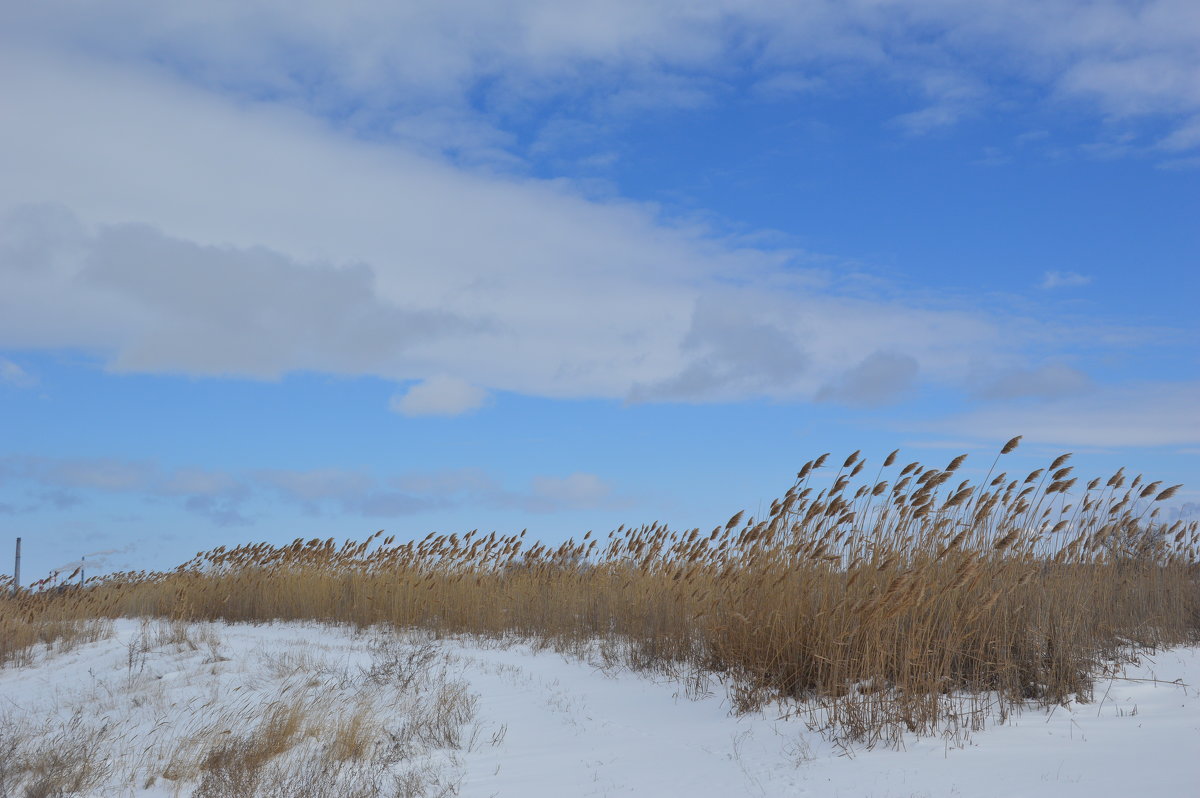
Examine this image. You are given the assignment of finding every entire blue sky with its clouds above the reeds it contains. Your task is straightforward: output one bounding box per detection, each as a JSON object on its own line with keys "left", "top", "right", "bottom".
{"left": 0, "top": 0, "right": 1200, "bottom": 580}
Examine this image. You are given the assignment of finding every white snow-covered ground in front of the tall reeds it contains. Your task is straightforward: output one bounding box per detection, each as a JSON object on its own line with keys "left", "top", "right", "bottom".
{"left": 0, "top": 620, "right": 1200, "bottom": 798}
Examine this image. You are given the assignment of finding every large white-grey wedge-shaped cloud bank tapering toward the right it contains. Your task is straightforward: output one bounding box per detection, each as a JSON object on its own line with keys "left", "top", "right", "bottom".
{"left": 0, "top": 50, "right": 1032, "bottom": 407}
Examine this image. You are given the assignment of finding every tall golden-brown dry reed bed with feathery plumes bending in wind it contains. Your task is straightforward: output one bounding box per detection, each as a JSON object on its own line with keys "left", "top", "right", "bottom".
{"left": 0, "top": 438, "right": 1200, "bottom": 743}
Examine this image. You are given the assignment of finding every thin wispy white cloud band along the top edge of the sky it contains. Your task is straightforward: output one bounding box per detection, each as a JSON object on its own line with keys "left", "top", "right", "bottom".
{"left": 0, "top": 0, "right": 1200, "bottom": 151}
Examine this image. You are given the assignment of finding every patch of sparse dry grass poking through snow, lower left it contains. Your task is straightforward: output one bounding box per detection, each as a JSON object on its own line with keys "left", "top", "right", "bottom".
{"left": 0, "top": 620, "right": 475, "bottom": 798}
